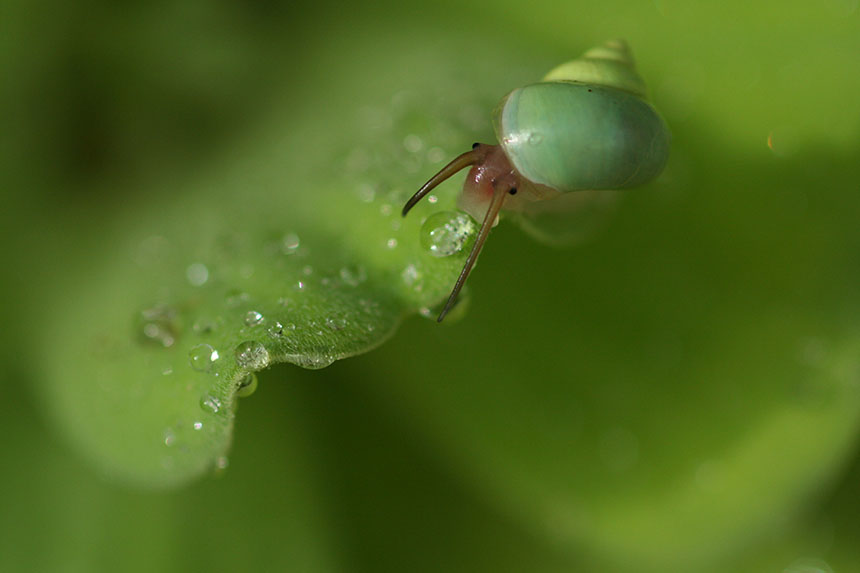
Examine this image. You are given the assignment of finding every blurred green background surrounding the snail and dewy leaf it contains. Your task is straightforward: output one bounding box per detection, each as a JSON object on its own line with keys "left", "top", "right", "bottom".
{"left": 0, "top": 0, "right": 860, "bottom": 572}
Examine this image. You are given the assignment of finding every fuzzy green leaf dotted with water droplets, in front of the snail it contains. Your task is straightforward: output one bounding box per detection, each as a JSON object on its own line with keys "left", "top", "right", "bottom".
{"left": 35, "top": 45, "right": 510, "bottom": 487}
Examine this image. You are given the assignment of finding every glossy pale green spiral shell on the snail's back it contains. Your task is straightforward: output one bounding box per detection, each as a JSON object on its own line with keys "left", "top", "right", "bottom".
{"left": 494, "top": 41, "right": 670, "bottom": 192}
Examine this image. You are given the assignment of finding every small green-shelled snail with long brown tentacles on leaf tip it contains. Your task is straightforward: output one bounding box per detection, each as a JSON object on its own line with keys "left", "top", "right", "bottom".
{"left": 403, "top": 40, "right": 670, "bottom": 322}
